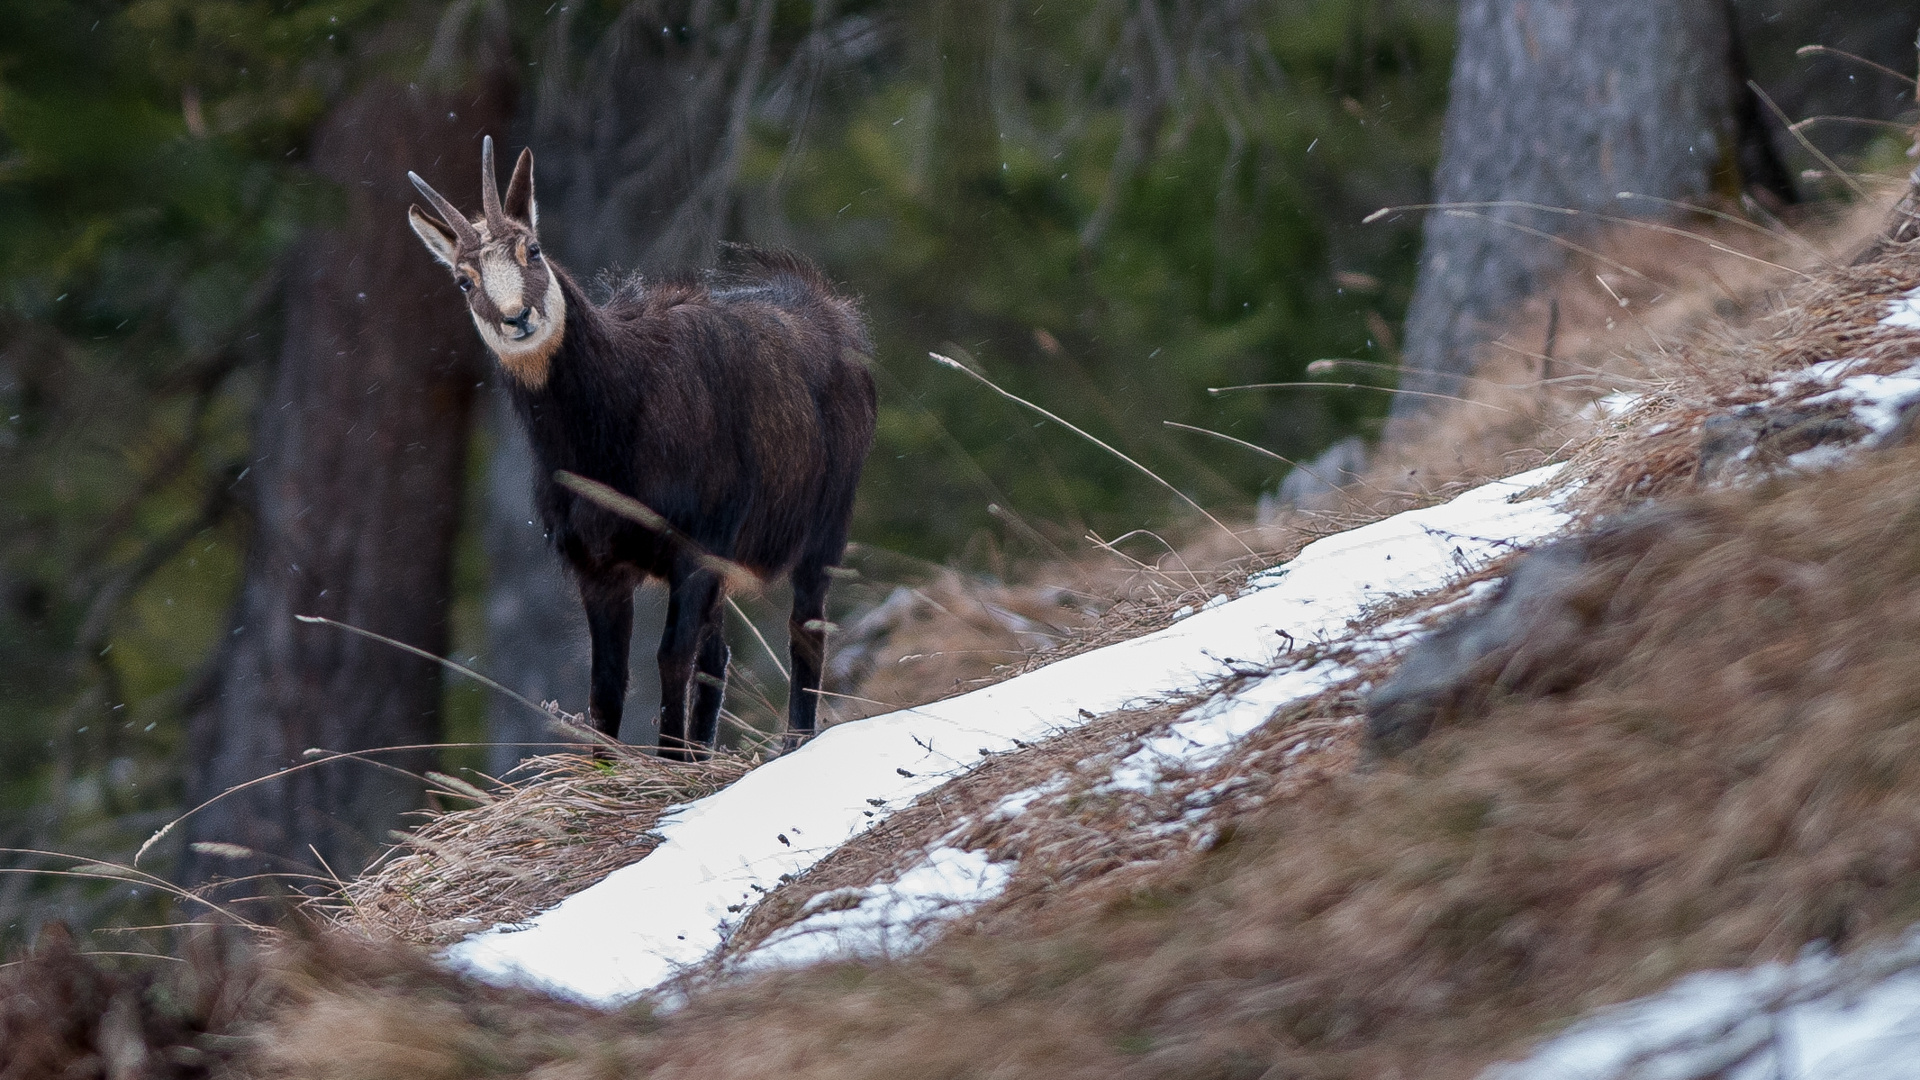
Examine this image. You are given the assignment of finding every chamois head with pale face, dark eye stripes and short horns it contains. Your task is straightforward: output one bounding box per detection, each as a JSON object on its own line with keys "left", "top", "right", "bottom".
{"left": 407, "top": 135, "right": 566, "bottom": 390}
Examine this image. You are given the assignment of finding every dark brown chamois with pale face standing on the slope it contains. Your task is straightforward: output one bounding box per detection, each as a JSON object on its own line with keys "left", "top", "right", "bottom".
{"left": 407, "top": 136, "right": 876, "bottom": 761}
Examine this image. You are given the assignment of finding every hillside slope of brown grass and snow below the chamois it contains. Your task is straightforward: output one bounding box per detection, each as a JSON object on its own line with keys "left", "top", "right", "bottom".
{"left": 15, "top": 180, "right": 1920, "bottom": 1080}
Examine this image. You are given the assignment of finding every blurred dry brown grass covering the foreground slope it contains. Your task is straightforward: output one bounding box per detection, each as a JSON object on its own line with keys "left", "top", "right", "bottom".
{"left": 337, "top": 432, "right": 1920, "bottom": 1078}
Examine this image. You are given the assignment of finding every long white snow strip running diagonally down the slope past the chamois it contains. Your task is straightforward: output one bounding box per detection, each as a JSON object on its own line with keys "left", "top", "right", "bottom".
{"left": 447, "top": 457, "right": 1569, "bottom": 1003}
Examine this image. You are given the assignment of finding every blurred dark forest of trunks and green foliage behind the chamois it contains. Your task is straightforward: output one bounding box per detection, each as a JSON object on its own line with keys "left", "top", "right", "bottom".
{"left": 0, "top": 0, "right": 1912, "bottom": 944}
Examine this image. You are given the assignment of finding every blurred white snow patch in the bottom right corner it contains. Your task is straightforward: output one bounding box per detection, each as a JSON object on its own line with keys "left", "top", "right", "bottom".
{"left": 1482, "top": 930, "right": 1920, "bottom": 1080}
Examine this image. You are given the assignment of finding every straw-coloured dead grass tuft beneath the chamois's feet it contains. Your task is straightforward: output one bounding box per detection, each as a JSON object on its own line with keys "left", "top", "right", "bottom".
{"left": 323, "top": 749, "right": 755, "bottom": 945}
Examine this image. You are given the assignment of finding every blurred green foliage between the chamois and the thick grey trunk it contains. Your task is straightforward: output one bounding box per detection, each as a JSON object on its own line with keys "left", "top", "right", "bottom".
{"left": 753, "top": 0, "right": 1452, "bottom": 559}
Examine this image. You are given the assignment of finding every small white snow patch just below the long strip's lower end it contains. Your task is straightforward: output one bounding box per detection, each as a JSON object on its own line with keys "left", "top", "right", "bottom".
{"left": 739, "top": 847, "right": 1012, "bottom": 970}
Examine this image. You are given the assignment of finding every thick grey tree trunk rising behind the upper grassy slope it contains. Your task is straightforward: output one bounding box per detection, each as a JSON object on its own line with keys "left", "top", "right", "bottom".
{"left": 1394, "top": 0, "right": 1793, "bottom": 419}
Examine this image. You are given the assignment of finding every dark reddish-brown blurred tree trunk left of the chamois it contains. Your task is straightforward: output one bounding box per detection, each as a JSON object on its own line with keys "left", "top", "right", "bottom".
{"left": 180, "top": 79, "right": 509, "bottom": 892}
